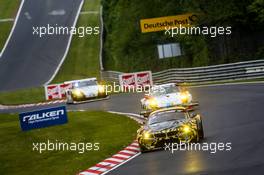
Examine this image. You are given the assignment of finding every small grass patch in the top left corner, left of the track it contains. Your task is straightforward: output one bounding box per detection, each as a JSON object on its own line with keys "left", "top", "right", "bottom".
{"left": 0, "top": 0, "right": 20, "bottom": 51}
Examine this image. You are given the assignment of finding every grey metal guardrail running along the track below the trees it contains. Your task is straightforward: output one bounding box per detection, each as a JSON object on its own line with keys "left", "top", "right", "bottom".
{"left": 102, "top": 60, "right": 264, "bottom": 84}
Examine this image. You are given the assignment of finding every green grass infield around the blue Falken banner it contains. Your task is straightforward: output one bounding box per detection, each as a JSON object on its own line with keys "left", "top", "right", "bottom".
{"left": 0, "top": 111, "right": 138, "bottom": 175}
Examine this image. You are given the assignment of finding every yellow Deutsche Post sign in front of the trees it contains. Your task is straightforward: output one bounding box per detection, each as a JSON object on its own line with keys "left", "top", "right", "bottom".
{"left": 140, "top": 13, "right": 197, "bottom": 33}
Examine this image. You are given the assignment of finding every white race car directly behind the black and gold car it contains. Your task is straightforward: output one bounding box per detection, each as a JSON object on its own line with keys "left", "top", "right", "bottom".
{"left": 140, "top": 83, "right": 198, "bottom": 117}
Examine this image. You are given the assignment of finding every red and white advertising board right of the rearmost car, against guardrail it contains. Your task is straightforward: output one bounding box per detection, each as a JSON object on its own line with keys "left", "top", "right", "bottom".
{"left": 119, "top": 71, "right": 153, "bottom": 89}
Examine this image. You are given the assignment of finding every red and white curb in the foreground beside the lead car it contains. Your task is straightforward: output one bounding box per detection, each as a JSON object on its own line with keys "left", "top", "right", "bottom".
{"left": 78, "top": 141, "right": 141, "bottom": 175}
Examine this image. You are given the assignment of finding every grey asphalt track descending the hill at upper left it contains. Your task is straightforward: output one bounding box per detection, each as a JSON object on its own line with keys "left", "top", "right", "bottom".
{"left": 0, "top": 0, "right": 83, "bottom": 91}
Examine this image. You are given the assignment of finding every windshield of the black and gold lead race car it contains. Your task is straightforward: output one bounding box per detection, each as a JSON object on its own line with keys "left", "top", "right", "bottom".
{"left": 148, "top": 111, "right": 185, "bottom": 125}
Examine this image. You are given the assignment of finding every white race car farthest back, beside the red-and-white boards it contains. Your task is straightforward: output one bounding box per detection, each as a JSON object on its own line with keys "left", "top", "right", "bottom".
{"left": 65, "top": 78, "right": 108, "bottom": 103}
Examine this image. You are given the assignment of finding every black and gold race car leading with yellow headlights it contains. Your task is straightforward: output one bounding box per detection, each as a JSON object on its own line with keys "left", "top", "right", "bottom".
{"left": 137, "top": 107, "right": 204, "bottom": 152}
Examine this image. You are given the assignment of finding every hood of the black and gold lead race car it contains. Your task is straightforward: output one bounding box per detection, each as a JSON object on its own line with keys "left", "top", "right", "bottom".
{"left": 148, "top": 119, "right": 187, "bottom": 132}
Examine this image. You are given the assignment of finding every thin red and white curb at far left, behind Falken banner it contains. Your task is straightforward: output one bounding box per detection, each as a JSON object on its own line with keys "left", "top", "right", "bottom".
{"left": 0, "top": 100, "right": 66, "bottom": 110}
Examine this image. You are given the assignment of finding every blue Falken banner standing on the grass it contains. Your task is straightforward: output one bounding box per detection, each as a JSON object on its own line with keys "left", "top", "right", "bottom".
{"left": 19, "top": 106, "right": 68, "bottom": 131}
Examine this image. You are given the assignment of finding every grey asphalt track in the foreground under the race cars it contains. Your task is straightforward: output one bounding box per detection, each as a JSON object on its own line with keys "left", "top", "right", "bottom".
{"left": 2, "top": 84, "right": 264, "bottom": 175}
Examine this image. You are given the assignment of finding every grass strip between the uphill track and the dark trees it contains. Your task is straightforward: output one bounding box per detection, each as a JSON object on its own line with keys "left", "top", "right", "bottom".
{"left": 52, "top": 0, "right": 100, "bottom": 83}
